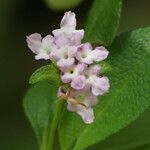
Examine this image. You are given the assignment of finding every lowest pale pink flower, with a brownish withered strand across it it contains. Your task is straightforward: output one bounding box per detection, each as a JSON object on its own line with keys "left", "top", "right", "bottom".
{"left": 58, "top": 88, "right": 97, "bottom": 124}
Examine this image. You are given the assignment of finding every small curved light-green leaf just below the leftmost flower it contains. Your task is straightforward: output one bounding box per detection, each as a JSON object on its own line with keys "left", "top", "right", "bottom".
{"left": 29, "top": 64, "right": 61, "bottom": 86}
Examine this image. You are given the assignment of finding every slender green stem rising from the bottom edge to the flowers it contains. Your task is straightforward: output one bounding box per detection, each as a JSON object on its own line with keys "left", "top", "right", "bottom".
{"left": 47, "top": 100, "right": 64, "bottom": 150}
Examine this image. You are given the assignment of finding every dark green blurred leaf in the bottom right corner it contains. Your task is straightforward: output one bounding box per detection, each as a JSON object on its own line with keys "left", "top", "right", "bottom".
{"left": 88, "top": 109, "right": 150, "bottom": 150}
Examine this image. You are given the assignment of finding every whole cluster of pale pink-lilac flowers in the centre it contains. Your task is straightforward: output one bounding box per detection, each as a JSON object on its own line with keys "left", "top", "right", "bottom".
{"left": 27, "top": 11, "right": 109, "bottom": 123}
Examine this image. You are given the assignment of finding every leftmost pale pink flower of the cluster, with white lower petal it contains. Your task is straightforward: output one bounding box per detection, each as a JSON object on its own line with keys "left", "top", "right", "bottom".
{"left": 26, "top": 33, "right": 54, "bottom": 60}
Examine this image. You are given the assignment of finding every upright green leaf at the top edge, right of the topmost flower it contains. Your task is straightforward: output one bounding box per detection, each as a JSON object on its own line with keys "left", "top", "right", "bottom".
{"left": 84, "top": 0, "right": 122, "bottom": 45}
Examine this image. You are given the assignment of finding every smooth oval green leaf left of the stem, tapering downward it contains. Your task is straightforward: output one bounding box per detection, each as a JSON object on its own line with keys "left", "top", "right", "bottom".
{"left": 24, "top": 82, "right": 57, "bottom": 144}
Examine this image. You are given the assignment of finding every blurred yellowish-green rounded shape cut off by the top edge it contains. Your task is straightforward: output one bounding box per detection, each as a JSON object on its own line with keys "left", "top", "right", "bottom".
{"left": 45, "top": 0, "right": 83, "bottom": 10}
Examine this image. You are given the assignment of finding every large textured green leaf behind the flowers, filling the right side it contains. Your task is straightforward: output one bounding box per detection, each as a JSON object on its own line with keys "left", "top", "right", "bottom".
{"left": 59, "top": 28, "right": 150, "bottom": 150}
